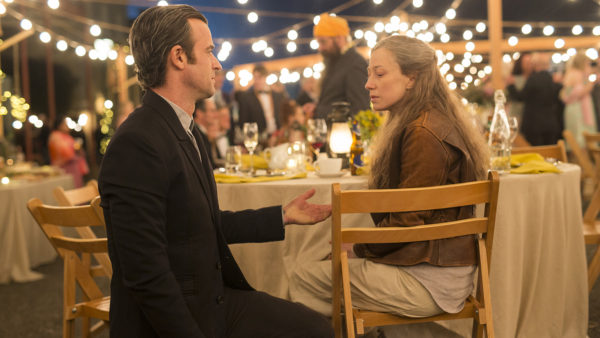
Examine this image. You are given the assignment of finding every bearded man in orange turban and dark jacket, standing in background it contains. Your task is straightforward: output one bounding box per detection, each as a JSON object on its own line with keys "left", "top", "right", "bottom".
{"left": 304, "top": 13, "right": 369, "bottom": 118}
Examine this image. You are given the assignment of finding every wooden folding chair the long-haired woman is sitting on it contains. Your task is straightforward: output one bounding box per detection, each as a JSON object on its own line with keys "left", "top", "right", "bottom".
{"left": 332, "top": 172, "right": 499, "bottom": 338}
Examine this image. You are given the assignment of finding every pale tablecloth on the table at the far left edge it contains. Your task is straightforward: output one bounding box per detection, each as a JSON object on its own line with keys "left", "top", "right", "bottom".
{"left": 0, "top": 175, "right": 74, "bottom": 283}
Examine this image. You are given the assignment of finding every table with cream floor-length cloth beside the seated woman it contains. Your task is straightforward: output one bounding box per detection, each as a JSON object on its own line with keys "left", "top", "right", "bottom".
{"left": 217, "top": 163, "right": 588, "bottom": 337}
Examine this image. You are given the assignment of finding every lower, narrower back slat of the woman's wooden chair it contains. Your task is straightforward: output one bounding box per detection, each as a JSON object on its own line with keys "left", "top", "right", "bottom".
{"left": 342, "top": 218, "right": 488, "bottom": 243}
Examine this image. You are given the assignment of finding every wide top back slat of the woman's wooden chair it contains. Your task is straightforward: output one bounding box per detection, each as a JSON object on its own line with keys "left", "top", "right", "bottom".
{"left": 340, "top": 182, "right": 489, "bottom": 214}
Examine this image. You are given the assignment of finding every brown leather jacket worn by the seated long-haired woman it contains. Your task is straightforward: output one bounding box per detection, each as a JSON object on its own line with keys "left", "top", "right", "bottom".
{"left": 354, "top": 111, "right": 477, "bottom": 266}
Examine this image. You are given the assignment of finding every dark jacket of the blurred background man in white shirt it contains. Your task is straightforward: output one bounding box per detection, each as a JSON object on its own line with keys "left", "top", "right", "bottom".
{"left": 237, "top": 87, "right": 284, "bottom": 133}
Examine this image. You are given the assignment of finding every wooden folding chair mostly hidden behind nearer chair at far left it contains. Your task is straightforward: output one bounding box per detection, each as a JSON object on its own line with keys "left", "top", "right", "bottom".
{"left": 53, "top": 180, "right": 112, "bottom": 278}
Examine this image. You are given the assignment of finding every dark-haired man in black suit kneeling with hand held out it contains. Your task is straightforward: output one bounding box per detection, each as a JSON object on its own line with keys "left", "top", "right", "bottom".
{"left": 99, "top": 5, "right": 333, "bottom": 337}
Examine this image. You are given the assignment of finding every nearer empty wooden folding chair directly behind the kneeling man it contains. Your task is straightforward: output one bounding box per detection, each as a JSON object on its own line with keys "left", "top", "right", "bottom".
{"left": 27, "top": 198, "right": 110, "bottom": 338}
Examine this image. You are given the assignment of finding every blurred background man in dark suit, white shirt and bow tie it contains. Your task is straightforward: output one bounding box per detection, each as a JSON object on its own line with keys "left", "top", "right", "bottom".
{"left": 237, "top": 64, "right": 285, "bottom": 143}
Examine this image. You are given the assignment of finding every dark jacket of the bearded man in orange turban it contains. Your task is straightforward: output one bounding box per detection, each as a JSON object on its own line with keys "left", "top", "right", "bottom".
{"left": 314, "top": 47, "right": 371, "bottom": 118}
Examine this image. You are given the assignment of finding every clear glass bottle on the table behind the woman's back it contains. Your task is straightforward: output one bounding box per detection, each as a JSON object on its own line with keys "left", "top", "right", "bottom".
{"left": 488, "top": 89, "right": 511, "bottom": 172}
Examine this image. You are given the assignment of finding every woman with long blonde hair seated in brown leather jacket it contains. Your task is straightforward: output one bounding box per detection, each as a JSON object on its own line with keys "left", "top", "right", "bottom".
{"left": 295, "top": 36, "right": 489, "bottom": 324}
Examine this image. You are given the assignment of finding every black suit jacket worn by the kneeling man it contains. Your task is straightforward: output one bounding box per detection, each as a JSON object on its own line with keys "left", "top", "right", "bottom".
{"left": 99, "top": 91, "right": 284, "bottom": 337}
